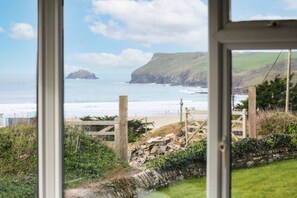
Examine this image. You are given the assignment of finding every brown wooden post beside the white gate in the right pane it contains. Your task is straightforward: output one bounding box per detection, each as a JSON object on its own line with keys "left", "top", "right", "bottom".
{"left": 248, "top": 87, "right": 257, "bottom": 137}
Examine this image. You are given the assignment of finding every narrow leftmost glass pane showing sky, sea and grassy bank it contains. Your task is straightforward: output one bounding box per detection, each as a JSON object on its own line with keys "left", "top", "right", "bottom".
{"left": 0, "top": 0, "right": 37, "bottom": 197}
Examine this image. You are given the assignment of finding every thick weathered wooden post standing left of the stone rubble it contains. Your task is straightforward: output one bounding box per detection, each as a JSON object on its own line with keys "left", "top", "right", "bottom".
{"left": 115, "top": 96, "right": 128, "bottom": 161}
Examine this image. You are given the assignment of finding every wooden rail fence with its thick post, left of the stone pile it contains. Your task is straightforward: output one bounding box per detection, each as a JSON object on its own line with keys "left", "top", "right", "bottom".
{"left": 65, "top": 96, "right": 128, "bottom": 161}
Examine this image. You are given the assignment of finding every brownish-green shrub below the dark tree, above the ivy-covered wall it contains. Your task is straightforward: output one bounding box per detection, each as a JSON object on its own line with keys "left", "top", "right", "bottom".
{"left": 257, "top": 111, "right": 297, "bottom": 135}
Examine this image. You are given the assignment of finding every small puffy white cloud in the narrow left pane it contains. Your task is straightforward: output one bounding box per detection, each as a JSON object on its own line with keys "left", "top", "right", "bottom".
{"left": 10, "top": 23, "right": 36, "bottom": 40}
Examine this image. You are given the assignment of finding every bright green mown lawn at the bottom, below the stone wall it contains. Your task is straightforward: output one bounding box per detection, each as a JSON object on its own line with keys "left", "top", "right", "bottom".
{"left": 145, "top": 159, "right": 297, "bottom": 198}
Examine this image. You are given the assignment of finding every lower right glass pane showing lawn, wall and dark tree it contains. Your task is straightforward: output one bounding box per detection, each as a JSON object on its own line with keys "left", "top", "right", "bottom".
{"left": 231, "top": 49, "right": 297, "bottom": 197}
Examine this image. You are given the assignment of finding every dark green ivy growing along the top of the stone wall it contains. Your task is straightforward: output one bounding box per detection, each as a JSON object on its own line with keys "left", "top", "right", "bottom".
{"left": 147, "top": 133, "right": 297, "bottom": 170}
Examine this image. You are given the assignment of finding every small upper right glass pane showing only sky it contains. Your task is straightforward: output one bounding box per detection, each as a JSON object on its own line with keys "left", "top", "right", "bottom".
{"left": 230, "top": 0, "right": 297, "bottom": 21}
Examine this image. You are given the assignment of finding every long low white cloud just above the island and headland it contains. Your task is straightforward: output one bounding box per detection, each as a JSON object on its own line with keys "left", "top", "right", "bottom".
{"left": 67, "top": 48, "right": 153, "bottom": 68}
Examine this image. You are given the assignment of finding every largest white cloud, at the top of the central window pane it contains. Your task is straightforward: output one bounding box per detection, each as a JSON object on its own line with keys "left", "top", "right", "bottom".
{"left": 86, "top": 0, "right": 208, "bottom": 49}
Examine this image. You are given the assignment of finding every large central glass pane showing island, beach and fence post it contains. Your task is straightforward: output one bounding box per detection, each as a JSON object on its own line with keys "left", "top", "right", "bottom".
{"left": 64, "top": 0, "right": 208, "bottom": 197}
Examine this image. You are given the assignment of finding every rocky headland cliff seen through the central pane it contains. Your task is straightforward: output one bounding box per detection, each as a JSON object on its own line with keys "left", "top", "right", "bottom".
{"left": 130, "top": 52, "right": 207, "bottom": 87}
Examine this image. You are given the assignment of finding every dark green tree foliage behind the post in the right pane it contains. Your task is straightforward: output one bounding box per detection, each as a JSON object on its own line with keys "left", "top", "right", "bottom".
{"left": 236, "top": 75, "right": 297, "bottom": 111}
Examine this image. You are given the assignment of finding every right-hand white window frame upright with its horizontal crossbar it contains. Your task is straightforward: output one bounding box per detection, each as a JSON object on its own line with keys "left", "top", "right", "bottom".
{"left": 207, "top": 0, "right": 297, "bottom": 198}
